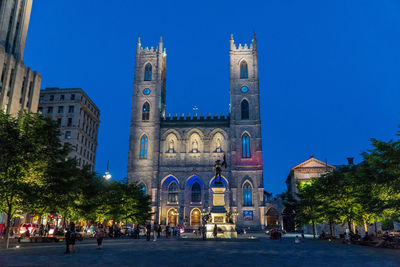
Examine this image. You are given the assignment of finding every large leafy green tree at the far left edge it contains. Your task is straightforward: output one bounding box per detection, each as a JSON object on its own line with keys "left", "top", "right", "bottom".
{"left": 0, "top": 112, "right": 65, "bottom": 248}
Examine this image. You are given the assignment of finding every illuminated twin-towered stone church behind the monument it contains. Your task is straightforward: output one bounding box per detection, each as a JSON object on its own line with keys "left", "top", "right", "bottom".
{"left": 128, "top": 35, "right": 265, "bottom": 229}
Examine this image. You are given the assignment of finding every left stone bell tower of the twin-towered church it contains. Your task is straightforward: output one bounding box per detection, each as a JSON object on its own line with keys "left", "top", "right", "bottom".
{"left": 128, "top": 37, "right": 167, "bottom": 209}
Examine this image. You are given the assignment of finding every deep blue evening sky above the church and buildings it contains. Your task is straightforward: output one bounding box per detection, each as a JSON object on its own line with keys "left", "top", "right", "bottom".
{"left": 24, "top": 0, "right": 400, "bottom": 194}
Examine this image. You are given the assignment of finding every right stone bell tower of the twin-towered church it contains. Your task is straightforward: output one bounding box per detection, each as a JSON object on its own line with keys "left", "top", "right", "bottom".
{"left": 229, "top": 34, "right": 264, "bottom": 226}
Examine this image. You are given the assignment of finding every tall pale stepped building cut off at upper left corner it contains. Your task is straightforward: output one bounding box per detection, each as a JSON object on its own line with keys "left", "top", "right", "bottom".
{"left": 0, "top": 0, "right": 42, "bottom": 115}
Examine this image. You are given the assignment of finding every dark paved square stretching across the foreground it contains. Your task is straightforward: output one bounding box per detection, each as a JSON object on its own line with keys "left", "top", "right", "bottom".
{"left": 0, "top": 235, "right": 400, "bottom": 266}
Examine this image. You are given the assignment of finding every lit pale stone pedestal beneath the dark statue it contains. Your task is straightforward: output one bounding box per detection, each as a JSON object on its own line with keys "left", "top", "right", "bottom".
{"left": 206, "top": 182, "right": 237, "bottom": 238}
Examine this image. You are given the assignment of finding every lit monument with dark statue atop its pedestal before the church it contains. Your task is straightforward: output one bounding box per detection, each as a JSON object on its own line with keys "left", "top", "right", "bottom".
{"left": 206, "top": 155, "right": 237, "bottom": 238}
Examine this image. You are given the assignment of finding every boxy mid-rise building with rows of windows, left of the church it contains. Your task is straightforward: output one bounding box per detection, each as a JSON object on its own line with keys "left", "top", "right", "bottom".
{"left": 38, "top": 88, "right": 100, "bottom": 170}
